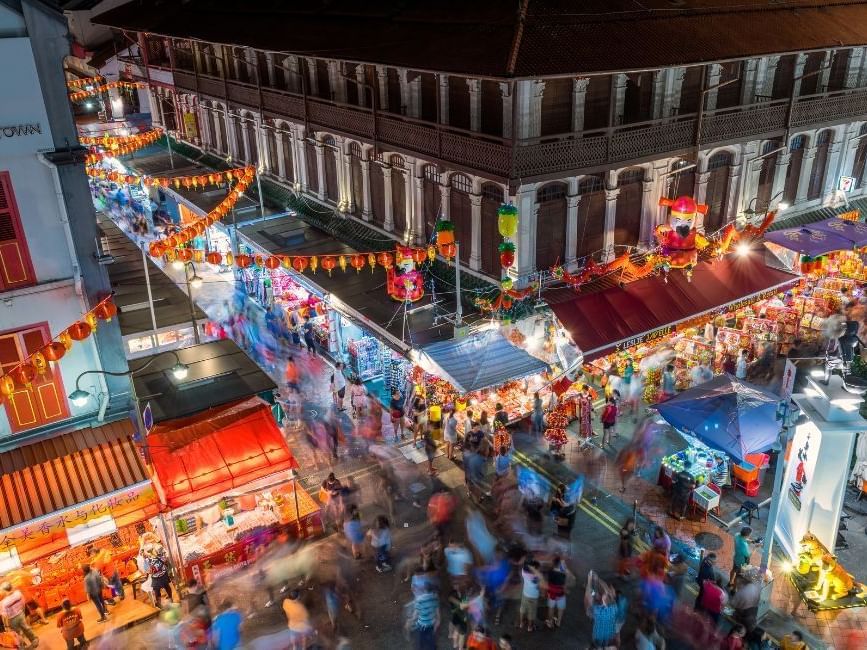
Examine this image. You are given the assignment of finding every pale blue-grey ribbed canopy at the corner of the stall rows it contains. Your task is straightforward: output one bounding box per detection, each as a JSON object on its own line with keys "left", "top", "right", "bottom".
{"left": 416, "top": 330, "right": 548, "bottom": 393}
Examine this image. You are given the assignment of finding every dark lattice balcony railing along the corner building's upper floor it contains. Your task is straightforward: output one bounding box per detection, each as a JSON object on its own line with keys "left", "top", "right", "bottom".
{"left": 174, "top": 70, "right": 867, "bottom": 180}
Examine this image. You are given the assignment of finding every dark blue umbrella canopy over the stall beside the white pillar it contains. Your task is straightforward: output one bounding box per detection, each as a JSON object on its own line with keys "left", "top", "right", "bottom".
{"left": 655, "top": 374, "right": 780, "bottom": 462}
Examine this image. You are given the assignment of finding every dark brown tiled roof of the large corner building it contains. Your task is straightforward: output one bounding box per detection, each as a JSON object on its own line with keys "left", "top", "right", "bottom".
{"left": 94, "top": 0, "right": 867, "bottom": 77}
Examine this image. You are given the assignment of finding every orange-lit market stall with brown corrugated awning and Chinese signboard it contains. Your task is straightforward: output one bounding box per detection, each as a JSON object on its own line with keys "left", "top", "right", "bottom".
{"left": 0, "top": 421, "right": 159, "bottom": 619}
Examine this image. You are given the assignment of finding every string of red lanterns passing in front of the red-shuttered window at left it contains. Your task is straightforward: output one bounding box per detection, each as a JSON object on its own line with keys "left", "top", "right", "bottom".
{"left": 0, "top": 295, "right": 117, "bottom": 397}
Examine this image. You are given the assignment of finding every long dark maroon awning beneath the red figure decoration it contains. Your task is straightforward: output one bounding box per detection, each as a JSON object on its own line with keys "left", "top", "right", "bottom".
{"left": 549, "top": 252, "right": 800, "bottom": 361}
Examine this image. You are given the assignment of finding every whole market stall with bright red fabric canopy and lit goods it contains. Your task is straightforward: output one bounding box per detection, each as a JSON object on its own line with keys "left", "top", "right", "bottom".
{"left": 148, "top": 398, "right": 321, "bottom": 582}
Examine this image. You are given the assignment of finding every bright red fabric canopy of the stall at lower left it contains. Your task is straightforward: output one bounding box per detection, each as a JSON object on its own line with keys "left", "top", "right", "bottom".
{"left": 148, "top": 397, "right": 298, "bottom": 508}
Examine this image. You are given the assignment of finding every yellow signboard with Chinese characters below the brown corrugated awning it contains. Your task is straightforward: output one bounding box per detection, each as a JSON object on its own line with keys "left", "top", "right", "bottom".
{"left": 0, "top": 481, "right": 157, "bottom": 562}
